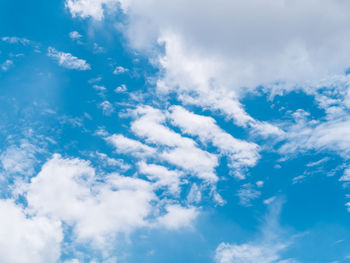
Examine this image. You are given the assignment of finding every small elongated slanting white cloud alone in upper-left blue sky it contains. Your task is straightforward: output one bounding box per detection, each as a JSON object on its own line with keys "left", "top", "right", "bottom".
{"left": 47, "top": 47, "right": 91, "bottom": 70}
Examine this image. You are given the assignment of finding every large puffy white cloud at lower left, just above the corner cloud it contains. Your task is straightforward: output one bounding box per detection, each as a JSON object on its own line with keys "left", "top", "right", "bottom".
{"left": 26, "top": 155, "right": 156, "bottom": 245}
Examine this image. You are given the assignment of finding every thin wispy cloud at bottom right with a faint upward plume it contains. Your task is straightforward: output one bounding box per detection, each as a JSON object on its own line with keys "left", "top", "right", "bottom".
{"left": 215, "top": 200, "right": 297, "bottom": 263}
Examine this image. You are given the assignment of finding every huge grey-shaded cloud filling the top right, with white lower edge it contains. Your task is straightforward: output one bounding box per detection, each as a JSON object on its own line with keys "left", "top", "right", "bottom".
{"left": 66, "top": 0, "right": 350, "bottom": 132}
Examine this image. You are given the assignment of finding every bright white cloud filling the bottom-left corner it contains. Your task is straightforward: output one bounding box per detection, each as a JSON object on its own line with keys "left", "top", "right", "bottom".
{"left": 0, "top": 199, "right": 63, "bottom": 263}
